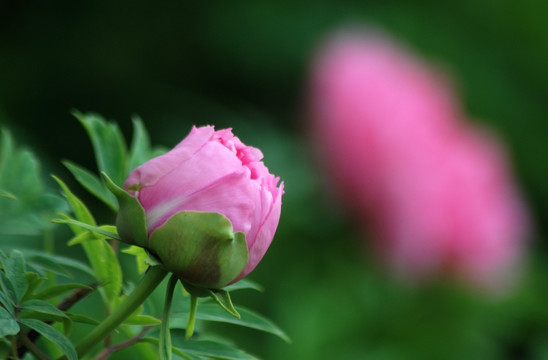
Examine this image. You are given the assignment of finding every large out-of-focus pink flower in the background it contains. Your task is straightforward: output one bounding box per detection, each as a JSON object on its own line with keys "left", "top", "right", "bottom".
{"left": 311, "top": 32, "right": 527, "bottom": 286}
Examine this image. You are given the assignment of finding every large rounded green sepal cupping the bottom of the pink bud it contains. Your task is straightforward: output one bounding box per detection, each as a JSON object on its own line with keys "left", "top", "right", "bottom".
{"left": 148, "top": 211, "right": 249, "bottom": 295}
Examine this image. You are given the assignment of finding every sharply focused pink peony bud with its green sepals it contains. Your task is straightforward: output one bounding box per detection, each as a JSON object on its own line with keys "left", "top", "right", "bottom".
{"left": 109, "top": 126, "right": 283, "bottom": 289}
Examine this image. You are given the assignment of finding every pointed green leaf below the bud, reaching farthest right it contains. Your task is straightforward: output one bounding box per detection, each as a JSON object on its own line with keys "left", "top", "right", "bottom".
{"left": 171, "top": 304, "right": 291, "bottom": 343}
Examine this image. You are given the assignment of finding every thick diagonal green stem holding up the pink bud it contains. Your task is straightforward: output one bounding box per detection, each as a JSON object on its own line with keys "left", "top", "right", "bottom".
{"left": 67, "top": 266, "right": 168, "bottom": 358}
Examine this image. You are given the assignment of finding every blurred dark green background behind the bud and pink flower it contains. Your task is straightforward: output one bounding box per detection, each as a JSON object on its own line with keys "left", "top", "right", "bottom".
{"left": 0, "top": 0, "right": 548, "bottom": 360}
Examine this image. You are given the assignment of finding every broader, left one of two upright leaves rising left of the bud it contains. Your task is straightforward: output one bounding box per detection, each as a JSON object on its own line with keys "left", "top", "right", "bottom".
{"left": 73, "top": 112, "right": 127, "bottom": 185}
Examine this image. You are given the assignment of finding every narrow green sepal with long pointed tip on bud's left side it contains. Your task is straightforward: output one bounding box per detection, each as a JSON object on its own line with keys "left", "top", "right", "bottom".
{"left": 101, "top": 172, "right": 147, "bottom": 247}
